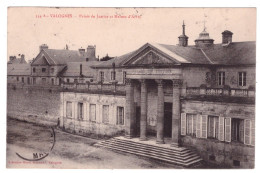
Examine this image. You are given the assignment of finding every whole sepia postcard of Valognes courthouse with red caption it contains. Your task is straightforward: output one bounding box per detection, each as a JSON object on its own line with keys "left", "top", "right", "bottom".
{"left": 6, "top": 7, "right": 256, "bottom": 169}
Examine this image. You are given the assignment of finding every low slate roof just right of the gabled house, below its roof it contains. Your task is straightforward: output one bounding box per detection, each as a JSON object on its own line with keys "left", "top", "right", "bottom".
{"left": 61, "top": 61, "right": 100, "bottom": 77}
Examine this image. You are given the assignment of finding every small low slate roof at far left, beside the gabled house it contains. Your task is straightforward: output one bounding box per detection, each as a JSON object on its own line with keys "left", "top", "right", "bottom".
{"left": 7, "top": 64, "right": 31, "bottom": 76}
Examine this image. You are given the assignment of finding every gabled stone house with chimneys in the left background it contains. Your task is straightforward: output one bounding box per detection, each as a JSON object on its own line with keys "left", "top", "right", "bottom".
{"left": 31, "top": 44, "right": 97, "bottom": 85}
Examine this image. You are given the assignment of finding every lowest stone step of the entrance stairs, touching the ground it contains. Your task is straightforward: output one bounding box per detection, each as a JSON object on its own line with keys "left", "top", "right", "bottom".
{"left": 94, "top": 142, "right": 202, "bottom": 167}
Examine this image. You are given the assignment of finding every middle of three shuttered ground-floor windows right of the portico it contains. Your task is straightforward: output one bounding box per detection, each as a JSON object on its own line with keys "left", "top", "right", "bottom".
{"left": 208, "top": 116, "right": 219, "bottom": 139}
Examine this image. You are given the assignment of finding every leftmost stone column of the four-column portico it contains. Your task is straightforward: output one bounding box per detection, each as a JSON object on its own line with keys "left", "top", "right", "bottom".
{"left": 125, "top": 79, "right": 135, "bottom": 138}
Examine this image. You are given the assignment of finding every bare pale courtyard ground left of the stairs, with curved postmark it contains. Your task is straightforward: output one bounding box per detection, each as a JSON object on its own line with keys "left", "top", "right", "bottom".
{"left": 6, "top": 119, "right": 182, "bottom": 169}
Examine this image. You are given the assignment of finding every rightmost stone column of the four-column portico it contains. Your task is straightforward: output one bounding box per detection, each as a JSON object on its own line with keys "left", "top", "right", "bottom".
{"left": 171, "top": 79, "right": 182, "bottom": 147}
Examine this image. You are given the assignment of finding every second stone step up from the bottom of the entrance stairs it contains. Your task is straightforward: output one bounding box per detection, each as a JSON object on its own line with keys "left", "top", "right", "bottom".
{"left": 95, "top": 141, "right": 200, "bottom": 163}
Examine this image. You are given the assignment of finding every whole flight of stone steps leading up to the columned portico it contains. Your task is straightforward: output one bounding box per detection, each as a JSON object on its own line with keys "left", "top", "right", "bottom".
{"left": 94, "top": 137, "right": 202, "bottom": 167}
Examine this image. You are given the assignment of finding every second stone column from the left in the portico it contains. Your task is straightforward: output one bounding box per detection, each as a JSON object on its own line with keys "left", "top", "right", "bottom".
{"left": 140, "top": 79, "right": 147, "bottom": 141}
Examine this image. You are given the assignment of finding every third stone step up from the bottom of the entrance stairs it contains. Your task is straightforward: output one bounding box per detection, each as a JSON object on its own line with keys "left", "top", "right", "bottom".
{"left": 97, "top": 140, "right": 197, "bottom": 160}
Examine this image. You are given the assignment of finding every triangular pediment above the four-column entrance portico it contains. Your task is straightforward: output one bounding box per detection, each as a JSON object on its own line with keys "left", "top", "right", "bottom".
{"left": 122, "top": 44, "right": 184, "bottom": 66}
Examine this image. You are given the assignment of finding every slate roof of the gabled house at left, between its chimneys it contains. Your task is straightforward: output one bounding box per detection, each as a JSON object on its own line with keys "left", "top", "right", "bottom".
{"left": 32, "top": 49, "right": 95, "bottom": 65}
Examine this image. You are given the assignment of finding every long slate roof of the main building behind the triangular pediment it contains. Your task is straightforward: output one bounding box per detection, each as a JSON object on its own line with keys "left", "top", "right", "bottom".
{"left": 92, "top": 41, "right": 256, "bottom": 68}
